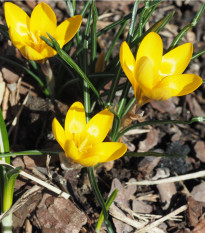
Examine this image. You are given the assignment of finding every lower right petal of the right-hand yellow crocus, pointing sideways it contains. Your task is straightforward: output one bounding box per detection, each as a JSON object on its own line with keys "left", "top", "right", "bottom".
{"left": 151, "top": 74, "right": 202, "bottom": 100}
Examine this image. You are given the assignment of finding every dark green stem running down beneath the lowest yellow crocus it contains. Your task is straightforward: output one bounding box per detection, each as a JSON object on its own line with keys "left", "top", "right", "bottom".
{"left": 87, "top": 167, "right": 114, "bottom": 233}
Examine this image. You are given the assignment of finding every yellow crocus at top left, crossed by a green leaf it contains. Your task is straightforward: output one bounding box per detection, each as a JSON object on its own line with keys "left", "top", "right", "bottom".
{"left": 4, "top": 2, "right": 82, "bottom": 63}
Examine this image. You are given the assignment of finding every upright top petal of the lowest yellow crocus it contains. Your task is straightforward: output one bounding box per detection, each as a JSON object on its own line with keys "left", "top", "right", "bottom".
{"left": 65, "top": 102, "right": 86, "bottom": 142}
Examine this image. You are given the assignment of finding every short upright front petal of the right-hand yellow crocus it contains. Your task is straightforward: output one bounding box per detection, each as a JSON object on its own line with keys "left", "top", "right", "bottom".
{"left": 135, "top": 57, "right": 156, "bottom": 90}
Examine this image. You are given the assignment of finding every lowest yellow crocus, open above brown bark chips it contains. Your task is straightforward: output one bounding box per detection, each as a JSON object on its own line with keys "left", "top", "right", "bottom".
{"left": 52, "top": 102, "right": 127, "bottom": 167}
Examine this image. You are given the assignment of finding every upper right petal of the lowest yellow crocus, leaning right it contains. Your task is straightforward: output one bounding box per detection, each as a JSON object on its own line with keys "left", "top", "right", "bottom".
{"left": 80, "top": 109, "right": 114, "bottom": 150}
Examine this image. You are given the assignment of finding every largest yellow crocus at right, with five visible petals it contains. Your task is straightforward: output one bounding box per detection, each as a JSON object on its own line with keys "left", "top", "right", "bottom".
{"left": 120, "top": 32, "right": 202, "bottom": 106}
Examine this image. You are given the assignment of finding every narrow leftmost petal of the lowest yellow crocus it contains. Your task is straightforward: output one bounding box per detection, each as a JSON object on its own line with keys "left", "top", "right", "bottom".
{"left": 52, "top": 118, "right": 66, "bottom": 149}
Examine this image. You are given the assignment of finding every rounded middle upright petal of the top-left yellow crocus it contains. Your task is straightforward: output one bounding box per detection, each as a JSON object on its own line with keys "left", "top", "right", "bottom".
{"left": 30, "top": 2, "right": 57, "bottom": 40}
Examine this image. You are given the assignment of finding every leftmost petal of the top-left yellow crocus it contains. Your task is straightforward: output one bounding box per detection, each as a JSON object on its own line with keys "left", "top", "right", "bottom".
{"left": 4, "top": 2, "right": 30, "bottom": 43}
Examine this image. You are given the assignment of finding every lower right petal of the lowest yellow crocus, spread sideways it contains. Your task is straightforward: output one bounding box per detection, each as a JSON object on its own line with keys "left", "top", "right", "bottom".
{"left": 83, "top": 142, "right": 127, "bottom": 163}
